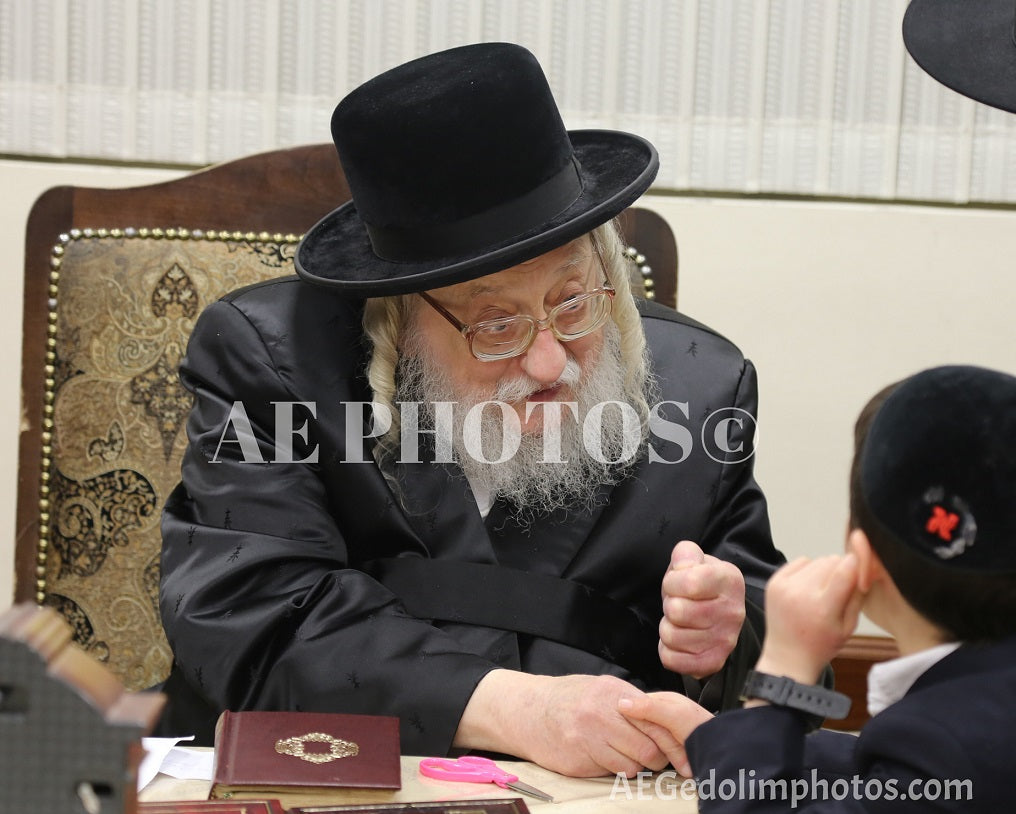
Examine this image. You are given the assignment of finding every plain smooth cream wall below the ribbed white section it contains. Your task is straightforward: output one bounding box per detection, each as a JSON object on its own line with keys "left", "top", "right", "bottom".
{"left": 0, "top": 161, "right": 1016, "bottom": 631}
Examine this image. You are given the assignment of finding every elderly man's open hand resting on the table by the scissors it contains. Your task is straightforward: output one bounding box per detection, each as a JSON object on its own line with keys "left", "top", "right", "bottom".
{"left": 454, "top": 670, "right": 668, "bottom": 777}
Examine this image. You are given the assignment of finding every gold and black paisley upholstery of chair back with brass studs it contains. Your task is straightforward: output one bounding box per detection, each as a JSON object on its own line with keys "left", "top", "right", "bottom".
{"left": 36, "top": 230, "right": 296, "bottom": 689}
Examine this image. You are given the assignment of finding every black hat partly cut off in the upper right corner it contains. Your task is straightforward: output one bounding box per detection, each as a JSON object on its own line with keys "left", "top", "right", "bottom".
{"left": 903, "top": 0, "right": 1016, "bottom": 113}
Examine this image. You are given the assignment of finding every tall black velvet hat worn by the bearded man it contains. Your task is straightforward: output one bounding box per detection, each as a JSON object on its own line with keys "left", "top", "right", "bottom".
{"left": 296, "top": 43, "right": 659, "bottom": 297}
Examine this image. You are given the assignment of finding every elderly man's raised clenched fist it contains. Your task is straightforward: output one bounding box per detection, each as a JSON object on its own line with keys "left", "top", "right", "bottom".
{"left": 659, "top": 540, "right": 745, "bottom": 679}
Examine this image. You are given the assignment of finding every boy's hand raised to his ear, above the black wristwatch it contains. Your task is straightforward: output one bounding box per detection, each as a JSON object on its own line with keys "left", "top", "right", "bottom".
{"left": 756, "top": 553, "right": 864, "bottom": 684}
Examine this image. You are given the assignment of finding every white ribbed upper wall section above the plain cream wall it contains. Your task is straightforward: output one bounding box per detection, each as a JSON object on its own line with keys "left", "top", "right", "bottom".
{"left": 0, "top": 0, "right": 1016, "bottom": 202}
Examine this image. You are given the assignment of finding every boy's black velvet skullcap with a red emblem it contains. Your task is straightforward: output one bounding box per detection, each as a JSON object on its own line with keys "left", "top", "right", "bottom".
{"left": 861, "top": 365, "right": 1016, "bottom": 573}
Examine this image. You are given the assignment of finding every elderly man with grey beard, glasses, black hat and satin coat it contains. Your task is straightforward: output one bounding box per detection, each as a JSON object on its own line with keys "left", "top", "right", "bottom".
{"left": 162, "top": 44, "right": 782, "bottom": 775}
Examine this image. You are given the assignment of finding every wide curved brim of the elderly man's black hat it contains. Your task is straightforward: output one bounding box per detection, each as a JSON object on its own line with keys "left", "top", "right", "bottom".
{"left": 296, "top": 130, "right": 659, "bottom": 297}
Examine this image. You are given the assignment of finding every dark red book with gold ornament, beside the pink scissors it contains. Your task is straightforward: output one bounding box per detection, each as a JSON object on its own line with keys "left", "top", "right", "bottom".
{"left": 211, "top": 711, "right": 402, "bottom": 808}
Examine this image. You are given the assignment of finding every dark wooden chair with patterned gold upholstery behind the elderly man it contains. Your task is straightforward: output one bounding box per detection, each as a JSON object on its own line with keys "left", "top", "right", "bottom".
{"left": 15, "top": 144, "right": 677, "bottom": 689}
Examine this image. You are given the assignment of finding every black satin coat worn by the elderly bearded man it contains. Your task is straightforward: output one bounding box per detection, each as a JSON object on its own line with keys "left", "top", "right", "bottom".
{"left": 161, "top": 278, "right": 782, "bottom": 754}
